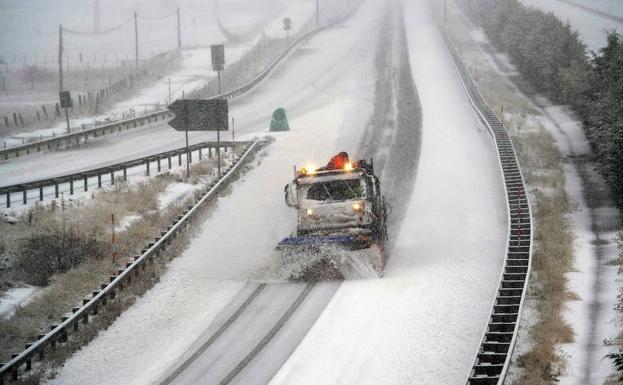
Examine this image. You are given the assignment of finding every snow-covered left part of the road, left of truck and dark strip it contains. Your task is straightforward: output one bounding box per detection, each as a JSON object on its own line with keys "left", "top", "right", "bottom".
{"left": 44, "top": 2, "right": 382, "bottom": 384}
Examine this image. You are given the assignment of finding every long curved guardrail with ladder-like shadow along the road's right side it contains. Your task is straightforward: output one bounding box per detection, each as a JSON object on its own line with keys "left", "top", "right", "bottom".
{"left": 439, "top": 27, "right": 534, "bottom": 385}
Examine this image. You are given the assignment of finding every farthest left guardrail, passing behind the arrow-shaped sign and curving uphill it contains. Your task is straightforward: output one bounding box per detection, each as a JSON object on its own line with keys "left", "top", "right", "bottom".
{"left": 0, "top": 15, "right": 336, "bottom": 160}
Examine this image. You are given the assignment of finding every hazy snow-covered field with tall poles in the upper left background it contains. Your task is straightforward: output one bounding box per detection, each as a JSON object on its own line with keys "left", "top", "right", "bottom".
{"left": 0, "top": 0, "right": 288, "bottom": 70}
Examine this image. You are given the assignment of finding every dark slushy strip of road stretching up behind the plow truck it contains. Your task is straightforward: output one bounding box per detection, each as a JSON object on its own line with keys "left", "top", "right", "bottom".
{"left": 360, "top": 1, "right": 422, "bottom": 243}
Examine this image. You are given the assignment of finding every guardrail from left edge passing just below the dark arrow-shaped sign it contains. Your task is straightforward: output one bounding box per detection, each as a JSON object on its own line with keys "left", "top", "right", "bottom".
{"left": 0, "top": 141, "right": 243, "bottom": 208}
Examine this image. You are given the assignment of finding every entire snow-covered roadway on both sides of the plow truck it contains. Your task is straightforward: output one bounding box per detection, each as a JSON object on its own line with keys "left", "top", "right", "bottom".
{"left": 42, "top": 0, "right": 507, "bottom": 384}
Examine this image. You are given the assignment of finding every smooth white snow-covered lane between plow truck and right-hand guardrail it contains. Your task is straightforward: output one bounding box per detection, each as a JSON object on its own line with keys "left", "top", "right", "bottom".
{"left": 271, "top": 1, "right": 506, "bottom": 385}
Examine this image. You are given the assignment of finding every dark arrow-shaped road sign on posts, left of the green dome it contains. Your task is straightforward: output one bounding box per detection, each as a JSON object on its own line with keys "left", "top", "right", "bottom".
{"left": 169, "top": 98, "right": 229, "bottom": 177}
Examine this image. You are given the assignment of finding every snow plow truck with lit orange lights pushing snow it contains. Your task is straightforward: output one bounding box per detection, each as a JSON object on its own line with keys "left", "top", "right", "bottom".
{"left": 277, "top": 152, "right": 387, "bottom": 281}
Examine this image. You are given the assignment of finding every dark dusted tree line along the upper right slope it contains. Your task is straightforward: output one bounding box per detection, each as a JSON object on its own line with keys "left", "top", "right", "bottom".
{"left": 461, "top": 0, "right": 623, "bottom": 208}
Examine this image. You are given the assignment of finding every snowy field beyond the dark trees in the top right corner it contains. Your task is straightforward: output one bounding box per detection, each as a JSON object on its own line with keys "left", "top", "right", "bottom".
{"left": 520, "top": 0, "right": 623, "bottom": 51}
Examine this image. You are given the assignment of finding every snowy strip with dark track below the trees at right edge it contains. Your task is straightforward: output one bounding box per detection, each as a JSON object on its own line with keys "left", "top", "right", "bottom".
{"left": 540, "top": 106, "right": 623, "bottom": 385}
